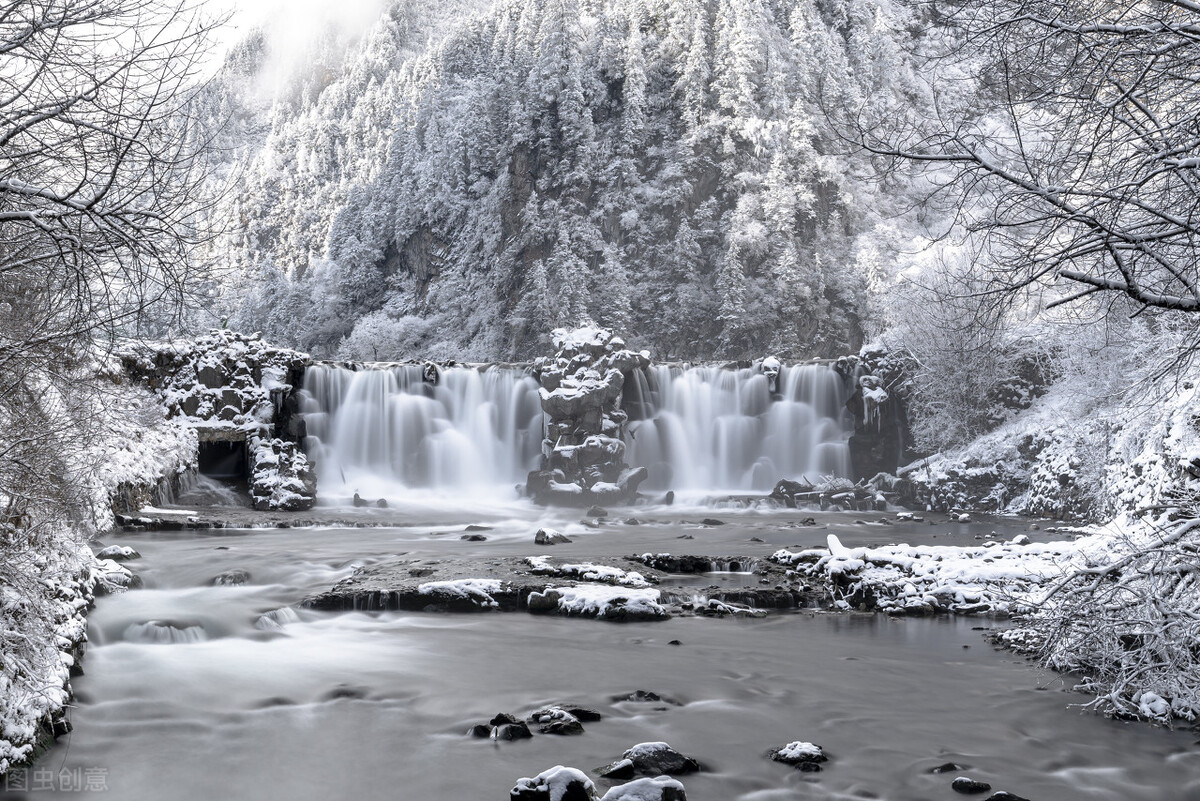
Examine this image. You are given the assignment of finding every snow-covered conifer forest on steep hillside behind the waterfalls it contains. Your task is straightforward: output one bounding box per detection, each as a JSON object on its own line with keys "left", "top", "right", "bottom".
{"left": 199, "top": 0, "right": 935, "bottom": 360}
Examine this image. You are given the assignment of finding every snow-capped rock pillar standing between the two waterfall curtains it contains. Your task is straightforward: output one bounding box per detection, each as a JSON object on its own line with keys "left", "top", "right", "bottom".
{"left": 526, "top": 326, "right": 649, "bottom": 507}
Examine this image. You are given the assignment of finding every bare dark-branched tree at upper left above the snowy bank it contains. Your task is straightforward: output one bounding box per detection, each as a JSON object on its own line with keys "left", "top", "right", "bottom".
{"left": 0, "top": 0, "right": 220, "bottom": 520}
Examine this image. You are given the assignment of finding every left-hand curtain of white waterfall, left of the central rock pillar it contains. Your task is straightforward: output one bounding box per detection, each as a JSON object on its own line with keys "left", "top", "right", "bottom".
{"left": 301, "top": 365, "right": 542, "bottom": 502}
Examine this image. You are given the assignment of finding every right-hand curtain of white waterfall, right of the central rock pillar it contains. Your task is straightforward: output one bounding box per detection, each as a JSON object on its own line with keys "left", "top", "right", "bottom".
{"left": 624, "top": 365, "right": 852, "bottom": 492}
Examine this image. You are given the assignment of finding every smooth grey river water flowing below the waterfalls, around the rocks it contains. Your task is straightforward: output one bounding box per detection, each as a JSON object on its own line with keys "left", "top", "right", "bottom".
{"left": 9, "top": 504, "right": 1200, "bottom": 801}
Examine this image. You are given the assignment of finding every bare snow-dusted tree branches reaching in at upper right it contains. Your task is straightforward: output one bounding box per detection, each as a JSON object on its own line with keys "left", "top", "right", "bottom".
{"left": 859, "top": 0, "right": 1200, "bottom": 312}
